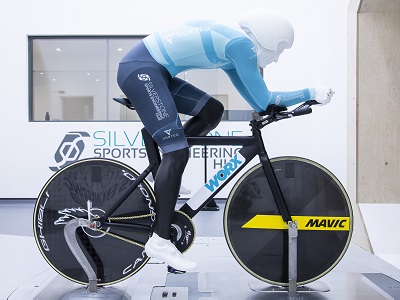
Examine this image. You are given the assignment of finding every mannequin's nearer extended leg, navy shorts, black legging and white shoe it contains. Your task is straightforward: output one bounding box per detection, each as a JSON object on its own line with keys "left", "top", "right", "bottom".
{"left": 119, "top": 63, "right": 196, "bottom": 270}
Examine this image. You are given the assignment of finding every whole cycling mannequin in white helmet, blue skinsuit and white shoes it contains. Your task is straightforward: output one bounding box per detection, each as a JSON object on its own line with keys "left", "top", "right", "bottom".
{"left": 117, "top": 10, "right": 333, "bottom": 271}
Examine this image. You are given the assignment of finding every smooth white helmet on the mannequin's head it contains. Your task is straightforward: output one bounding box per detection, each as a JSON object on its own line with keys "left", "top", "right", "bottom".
{"left": 239, "top": 9, "right": 294, "bottom": 51}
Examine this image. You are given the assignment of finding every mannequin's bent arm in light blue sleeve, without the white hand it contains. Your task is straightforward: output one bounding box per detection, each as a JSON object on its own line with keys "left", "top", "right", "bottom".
{"left": 224, "top": 39, "right": 315, "bottom": 112}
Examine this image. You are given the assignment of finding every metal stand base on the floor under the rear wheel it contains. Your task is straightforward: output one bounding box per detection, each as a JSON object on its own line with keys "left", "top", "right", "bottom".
{"left": 62, "top": 287, "right": 125, "bottom": 300}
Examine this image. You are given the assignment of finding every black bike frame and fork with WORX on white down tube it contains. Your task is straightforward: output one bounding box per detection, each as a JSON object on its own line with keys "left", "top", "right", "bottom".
{"left": 102, "top": 120, "right": 292, "bottom": 230}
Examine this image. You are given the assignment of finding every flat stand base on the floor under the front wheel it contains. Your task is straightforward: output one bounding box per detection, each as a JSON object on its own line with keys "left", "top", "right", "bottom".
{"left": 249, "top": 281, "right": 330, "bottom": 293}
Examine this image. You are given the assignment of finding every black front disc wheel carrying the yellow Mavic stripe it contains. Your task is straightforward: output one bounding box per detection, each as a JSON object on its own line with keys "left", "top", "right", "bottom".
{"left": 224, "top": 158, "right": 353, "bottom": 286}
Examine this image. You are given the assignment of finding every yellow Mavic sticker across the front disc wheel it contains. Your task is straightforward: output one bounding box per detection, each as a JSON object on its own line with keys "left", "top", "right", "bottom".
{"left": 242, "top": 215, "right": 350, "bottom": 231}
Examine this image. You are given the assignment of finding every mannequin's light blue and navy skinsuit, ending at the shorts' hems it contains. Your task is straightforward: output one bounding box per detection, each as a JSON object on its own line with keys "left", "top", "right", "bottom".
{"left": 118, "top": 21, "right": 310, "bottom": 152}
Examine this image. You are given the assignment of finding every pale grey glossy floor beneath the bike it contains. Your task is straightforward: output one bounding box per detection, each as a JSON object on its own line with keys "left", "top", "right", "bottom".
{"left": 0, "top": 200, "right": 400, "bottom": 300}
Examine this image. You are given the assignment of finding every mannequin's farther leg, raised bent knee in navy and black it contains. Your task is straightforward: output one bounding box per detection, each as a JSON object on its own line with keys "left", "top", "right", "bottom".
{"left": 169, "top": 78, "right": 224, "bottom": 136}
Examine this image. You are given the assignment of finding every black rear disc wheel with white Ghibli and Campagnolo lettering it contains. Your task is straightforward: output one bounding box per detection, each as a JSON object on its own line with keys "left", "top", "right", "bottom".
{"left": 34, "top": 159, "right": 154, "bottom": 285}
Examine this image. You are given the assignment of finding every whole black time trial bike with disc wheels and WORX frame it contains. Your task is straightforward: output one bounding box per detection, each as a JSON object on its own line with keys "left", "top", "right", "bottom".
{"left": 33, "top": 98, "right": 353, "bottom": 286}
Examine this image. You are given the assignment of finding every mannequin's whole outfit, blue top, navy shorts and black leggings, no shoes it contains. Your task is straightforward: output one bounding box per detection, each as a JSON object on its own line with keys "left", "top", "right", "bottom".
{"left": 117, "top": 21, "right": 310, "bottom": 239}
